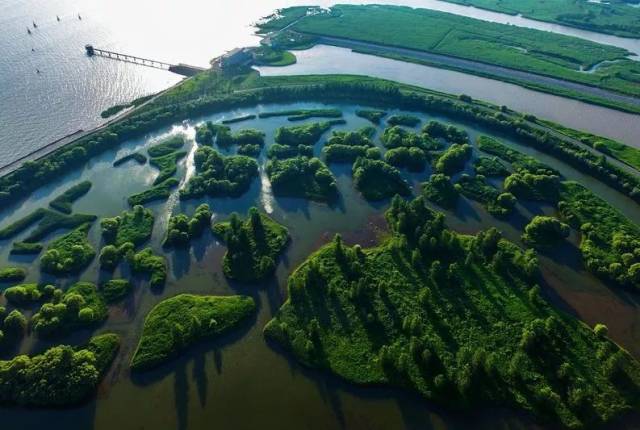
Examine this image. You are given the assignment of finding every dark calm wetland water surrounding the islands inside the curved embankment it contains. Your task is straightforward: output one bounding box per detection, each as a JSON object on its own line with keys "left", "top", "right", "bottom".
{"left": 0, "top": 104, "right": 640, "bottom": 430}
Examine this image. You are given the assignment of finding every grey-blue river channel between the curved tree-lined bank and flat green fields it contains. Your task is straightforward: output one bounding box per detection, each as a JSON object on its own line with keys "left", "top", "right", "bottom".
{"left": 258, "top": 45, "right": 640, "bottom": 147}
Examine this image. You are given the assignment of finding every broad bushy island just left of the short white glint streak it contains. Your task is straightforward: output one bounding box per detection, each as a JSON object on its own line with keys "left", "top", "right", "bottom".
{"left": 180, "top": 146, "right": 258, "bottom": 200}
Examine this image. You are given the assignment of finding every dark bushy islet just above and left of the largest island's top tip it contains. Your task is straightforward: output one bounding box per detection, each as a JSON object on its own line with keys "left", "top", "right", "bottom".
{"left": 353, "top": 158, "right": 411, "bottom": 201}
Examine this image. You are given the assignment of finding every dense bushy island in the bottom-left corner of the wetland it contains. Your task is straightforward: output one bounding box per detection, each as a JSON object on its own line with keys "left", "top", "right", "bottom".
{"left": 0, "top": 334, "right": 120, "bottom": 407}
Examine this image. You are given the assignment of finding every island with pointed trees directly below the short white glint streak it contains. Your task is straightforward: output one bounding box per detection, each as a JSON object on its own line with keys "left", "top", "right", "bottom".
{"left": 213, "top": 207, "right": 289, "bottom": 282}
